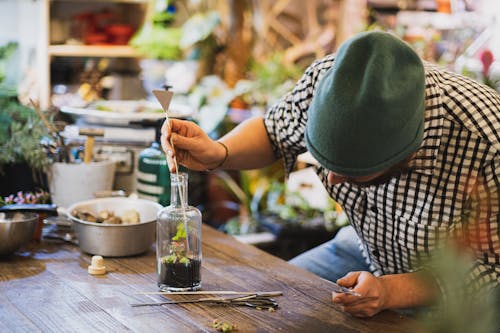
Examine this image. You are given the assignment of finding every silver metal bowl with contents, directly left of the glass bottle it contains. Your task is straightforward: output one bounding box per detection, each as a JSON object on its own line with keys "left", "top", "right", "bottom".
{"left": 67, "top": 198, "right": 162, "bottom": 257}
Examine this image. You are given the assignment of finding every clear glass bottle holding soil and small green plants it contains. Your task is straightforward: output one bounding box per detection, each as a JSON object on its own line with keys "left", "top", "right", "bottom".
{"left": 156, "top": 172, "right": 201, "bottom": 291}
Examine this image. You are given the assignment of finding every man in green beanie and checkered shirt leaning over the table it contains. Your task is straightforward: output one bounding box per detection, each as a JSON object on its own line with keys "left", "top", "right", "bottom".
{"left": 162, "top": 32, "right": 500, "bottom": 317}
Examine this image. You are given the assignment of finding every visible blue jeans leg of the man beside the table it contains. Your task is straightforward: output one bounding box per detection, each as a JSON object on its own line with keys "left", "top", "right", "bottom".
{"left": 289, "top": 226, "right": 370, "bottom": 282}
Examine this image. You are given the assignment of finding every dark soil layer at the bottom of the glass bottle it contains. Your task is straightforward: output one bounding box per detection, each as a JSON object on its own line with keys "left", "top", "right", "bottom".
{"left": 158, "top": 255, "right": 201, "bottom": 291}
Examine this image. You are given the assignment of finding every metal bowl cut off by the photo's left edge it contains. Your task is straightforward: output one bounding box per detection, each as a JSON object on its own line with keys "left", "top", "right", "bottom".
{"left": 0, "top": 212, "right": 38, "bottom": 256}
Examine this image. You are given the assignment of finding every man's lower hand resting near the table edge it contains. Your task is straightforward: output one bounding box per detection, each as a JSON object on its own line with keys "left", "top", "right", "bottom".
{"left": 332, "top": 272, "right": 388, "bottom": 317}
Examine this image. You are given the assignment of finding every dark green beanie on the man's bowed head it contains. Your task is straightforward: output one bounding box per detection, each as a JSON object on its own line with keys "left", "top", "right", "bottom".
{"left": 305, "top": 32, "right": 425, "bottom": 177}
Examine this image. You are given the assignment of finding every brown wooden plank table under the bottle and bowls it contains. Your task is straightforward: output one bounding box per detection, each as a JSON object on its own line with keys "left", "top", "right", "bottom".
{"left": 0, "top": 226, "right": 412, "bottom": 333}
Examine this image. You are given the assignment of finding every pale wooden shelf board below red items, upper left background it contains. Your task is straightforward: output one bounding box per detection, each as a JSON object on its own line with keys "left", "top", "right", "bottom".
{"left": 48, "top": 45, "right": 140, "bottom": 58}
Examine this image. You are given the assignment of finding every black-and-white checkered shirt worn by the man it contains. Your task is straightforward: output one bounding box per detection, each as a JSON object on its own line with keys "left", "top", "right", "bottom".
{"left": 264, "top": 55, "right": 500, "bottom": 296}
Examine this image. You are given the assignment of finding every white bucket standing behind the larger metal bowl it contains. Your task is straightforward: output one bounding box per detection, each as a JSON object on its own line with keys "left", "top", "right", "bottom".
{"left": 48, "top": 160, "right": 116, "bottom": 207}
